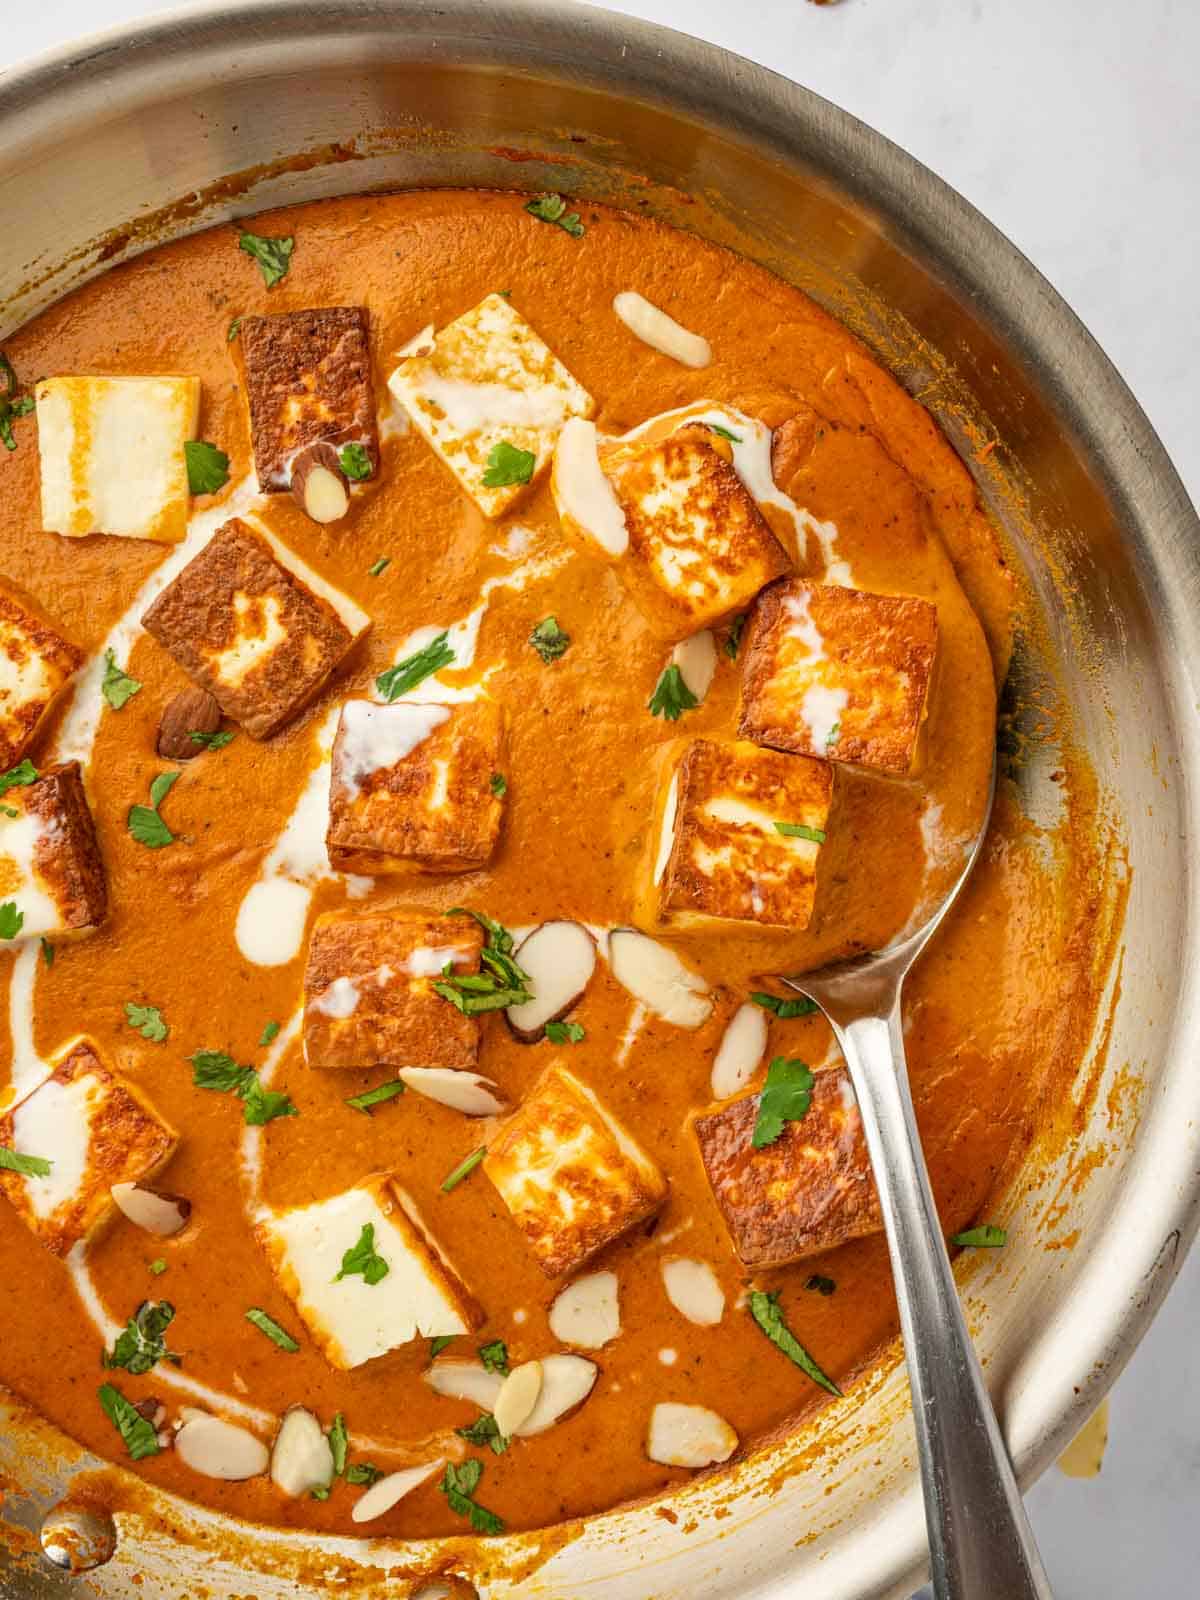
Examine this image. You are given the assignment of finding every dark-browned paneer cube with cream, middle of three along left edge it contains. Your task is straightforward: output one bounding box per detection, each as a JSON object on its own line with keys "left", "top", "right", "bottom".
{"left": 0, "top": 762, "right": 109, "bottom": 939}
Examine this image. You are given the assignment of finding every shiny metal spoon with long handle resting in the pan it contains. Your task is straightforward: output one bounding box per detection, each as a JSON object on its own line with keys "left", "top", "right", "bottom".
{"left": 784, "top": 771, "right": 1051, "bottom": 1600}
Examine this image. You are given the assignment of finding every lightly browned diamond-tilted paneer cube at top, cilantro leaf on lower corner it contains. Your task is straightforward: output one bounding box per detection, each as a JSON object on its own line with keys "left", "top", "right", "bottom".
{"left": 387, "top": 294, "right": 595, "bottom": 517}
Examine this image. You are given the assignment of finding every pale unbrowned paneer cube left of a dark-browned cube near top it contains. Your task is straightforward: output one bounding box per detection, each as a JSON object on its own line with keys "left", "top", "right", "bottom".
{"left": 37, "top": 378, "right": 200, "bottom": 544}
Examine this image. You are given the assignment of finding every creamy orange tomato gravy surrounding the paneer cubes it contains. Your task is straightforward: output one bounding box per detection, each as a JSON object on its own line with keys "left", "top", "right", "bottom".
{"left": 0, "top": 192, "right": 1091, "bottom": 1536}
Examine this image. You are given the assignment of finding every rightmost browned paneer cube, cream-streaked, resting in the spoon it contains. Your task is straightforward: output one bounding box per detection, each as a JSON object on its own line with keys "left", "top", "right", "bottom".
{"left": 738, "top": 578, "right": 938, "bottom": 776}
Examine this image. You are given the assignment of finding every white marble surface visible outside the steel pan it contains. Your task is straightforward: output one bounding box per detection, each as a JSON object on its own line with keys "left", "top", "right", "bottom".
{"left": 0, "top": 0, "right": 1200, "bottom": 1600}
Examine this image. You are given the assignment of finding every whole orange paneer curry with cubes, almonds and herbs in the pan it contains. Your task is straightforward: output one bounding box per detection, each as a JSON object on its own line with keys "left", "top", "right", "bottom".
{"left": 0, "top": 190, "right": 1088, "bottom": 1536}
